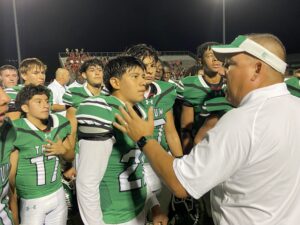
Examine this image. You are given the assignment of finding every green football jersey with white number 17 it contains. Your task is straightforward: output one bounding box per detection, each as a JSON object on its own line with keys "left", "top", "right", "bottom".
{"left": 13, "top": 114, "right": 71, "bottom": 199}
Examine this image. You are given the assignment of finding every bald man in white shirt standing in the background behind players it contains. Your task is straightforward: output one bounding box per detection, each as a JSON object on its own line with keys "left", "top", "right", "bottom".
{"left": 48, "top": 68, "right": 70, "bottom": 116}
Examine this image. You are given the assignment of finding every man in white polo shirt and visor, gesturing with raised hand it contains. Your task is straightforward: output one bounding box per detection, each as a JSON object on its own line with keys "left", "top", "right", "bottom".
{"left": 114, "top": 34, "right": 300, "bottom": 225}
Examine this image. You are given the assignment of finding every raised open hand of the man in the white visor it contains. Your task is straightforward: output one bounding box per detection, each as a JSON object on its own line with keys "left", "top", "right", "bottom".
{"left": 113, "top": 103, "right": 154, "bottom": 141}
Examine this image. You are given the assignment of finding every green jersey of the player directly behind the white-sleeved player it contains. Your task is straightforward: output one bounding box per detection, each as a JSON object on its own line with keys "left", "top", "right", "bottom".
{"left": 139, "top": 81, "right": 176, "bottom": 150}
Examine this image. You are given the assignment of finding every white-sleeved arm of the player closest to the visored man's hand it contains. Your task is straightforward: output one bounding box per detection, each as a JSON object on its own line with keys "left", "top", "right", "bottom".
{"left": 76, "top": 138, "right": 114, "bottom": 225}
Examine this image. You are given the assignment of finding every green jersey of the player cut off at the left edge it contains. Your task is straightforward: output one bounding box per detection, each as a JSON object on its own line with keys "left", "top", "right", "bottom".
{"left": 0, "top": 119, "right": 16, "bottom": 225}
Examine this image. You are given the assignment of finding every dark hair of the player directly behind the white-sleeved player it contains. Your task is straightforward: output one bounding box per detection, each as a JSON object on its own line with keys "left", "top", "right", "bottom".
{"left": 125, "top": 44, "right": 158, "bottom": 62}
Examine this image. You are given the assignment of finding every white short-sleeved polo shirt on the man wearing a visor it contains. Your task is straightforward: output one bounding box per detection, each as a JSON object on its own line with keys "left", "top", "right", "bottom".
{"left": 173, "top": 83, "right": 300, "bottom": 225}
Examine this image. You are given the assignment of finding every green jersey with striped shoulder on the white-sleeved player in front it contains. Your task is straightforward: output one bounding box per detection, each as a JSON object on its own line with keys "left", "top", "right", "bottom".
{"left": 76, "top": 96, "right": 147, "bottom": 224}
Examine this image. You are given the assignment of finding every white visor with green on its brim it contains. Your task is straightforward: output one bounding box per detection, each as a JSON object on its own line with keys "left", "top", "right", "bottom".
{"left": 212, "top": 35, "right": 287, "bottom": 74}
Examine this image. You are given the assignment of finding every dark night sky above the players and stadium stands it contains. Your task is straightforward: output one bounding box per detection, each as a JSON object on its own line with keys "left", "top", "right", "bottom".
{"left": 0, "top": 0, "right": 300, "bottom": 77}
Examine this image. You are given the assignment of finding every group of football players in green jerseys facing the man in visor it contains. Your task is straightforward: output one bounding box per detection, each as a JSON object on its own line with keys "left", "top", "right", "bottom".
{"left": 0, "top": 33, "right": 300, "bottom": 225}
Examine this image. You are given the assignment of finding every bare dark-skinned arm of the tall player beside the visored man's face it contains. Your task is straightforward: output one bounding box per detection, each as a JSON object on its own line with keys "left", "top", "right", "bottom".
{"left": 180, "top": 105, "right": 194, "bottom": 154}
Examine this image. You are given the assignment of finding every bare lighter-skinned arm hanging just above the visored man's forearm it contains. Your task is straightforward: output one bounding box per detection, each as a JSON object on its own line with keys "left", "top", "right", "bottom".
{"left": 164, "top": 110, "right": 183, "bottom": 157}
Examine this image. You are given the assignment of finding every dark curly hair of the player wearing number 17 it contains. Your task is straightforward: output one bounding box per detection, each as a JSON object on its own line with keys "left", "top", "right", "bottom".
{"left": 15, "top": 84, "right": 50, "bottom": 113}
